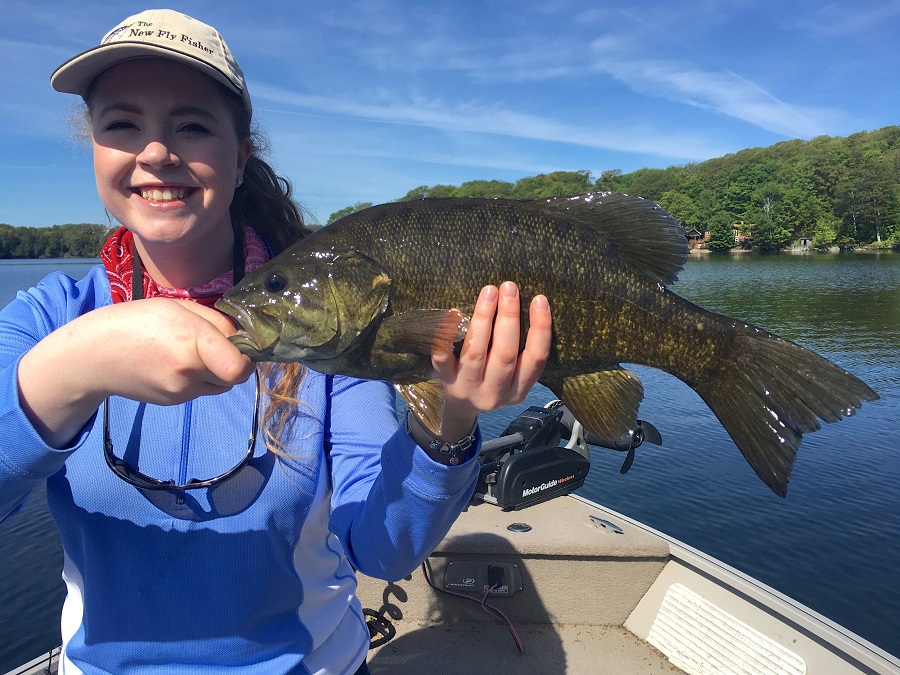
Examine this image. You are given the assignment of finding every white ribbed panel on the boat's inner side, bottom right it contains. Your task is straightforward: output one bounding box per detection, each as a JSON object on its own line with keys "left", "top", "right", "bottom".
{"left": 647, "top": 584, "right": 806, "bottom": 675}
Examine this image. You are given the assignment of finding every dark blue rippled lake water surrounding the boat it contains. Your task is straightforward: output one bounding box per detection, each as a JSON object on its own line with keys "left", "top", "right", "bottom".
{"left": 0, "top": 253, "right": 900, "bottom": 673}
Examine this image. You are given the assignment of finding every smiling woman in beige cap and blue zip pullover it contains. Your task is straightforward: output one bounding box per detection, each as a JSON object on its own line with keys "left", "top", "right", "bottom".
{"left": 0, "top": 10, "right": 551, "bottom": 675}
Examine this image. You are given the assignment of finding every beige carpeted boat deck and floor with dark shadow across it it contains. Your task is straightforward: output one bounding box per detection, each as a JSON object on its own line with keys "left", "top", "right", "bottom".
{"left": 359, "top": 499, "right": 682, "bottom": 675}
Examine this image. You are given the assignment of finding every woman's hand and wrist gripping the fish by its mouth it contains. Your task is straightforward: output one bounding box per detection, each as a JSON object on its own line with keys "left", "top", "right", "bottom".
{"left": 18, "top": 298, "right": 255, "bottom": 447}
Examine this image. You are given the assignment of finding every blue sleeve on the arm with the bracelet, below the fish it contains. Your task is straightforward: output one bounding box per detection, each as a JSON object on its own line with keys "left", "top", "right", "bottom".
{"left": 326, "top": 378, "right": 481, "bottom": 581}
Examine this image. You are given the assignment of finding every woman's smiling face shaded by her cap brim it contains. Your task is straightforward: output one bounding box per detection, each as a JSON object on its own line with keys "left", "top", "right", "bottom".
{"left": 90, "top": 59, "right": 251, "bottom": 262}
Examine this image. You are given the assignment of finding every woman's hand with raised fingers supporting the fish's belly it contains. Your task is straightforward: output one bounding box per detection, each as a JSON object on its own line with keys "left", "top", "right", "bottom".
{"left": 432, "top": 281, "right": 552, "bottom": 442}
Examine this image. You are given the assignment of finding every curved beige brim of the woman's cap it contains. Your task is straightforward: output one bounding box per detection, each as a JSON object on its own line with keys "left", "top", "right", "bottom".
{"left": 50, "top": 42, "right": 247, "bottom": 99}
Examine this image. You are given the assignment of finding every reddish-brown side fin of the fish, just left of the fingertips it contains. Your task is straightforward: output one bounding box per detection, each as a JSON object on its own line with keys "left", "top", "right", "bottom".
{"left": 376, "top": 309, "right": 469, "bottom": 354}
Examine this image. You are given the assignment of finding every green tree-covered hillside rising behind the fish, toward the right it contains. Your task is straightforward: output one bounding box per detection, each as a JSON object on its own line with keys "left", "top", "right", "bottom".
{"left": 329, "top": 126, "right": 900, "bottom": 250}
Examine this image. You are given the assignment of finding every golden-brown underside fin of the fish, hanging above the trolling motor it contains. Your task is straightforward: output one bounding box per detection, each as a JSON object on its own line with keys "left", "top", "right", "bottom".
{"left": 545, "top": 366, "right": 644, "bottom": 439}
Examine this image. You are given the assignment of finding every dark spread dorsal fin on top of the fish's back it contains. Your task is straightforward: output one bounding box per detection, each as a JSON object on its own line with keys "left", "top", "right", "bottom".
{"left": 531, "top": 192, "right": 688, "bottom": 286}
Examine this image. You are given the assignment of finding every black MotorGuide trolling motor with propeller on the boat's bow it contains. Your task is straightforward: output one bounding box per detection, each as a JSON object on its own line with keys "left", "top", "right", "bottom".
{"left": 472, "top": 401, "right": 662, "bottom": 511}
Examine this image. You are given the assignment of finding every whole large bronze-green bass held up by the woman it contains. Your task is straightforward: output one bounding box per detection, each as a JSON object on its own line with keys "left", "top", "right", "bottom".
{"left": 218, "top": 193, "right": 878, "bottom": 496}
